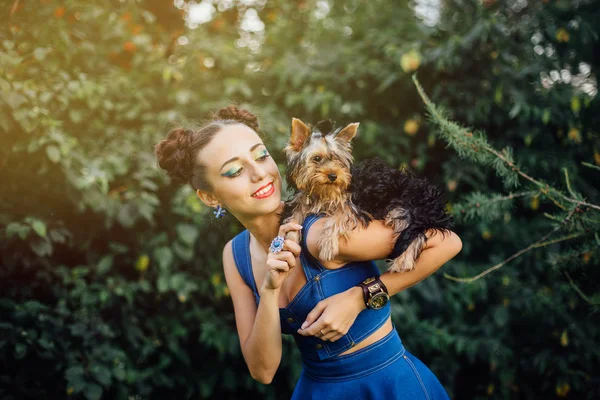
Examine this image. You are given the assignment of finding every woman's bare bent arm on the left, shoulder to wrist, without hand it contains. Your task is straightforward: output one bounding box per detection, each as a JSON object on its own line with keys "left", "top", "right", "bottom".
{"left": 223, "top": 241, "right": 281, "bottom": 384}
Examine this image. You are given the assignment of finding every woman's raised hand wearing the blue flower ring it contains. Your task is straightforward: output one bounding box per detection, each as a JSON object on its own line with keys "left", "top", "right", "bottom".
{"left": 262, "top": 221, "right": 302, "bottom": 290}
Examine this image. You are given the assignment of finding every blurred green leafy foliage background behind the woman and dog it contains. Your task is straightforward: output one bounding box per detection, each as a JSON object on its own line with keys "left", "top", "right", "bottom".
{"left": 0, "top": 0, "right": 600, "bottom": 400}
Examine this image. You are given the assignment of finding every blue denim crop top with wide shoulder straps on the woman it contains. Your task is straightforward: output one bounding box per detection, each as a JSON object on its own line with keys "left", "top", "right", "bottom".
{"left": 232, "top": 215, "right": 390, "bottom": 360}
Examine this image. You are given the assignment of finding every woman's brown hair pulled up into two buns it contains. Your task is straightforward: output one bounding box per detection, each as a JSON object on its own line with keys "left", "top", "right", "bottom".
{"left": 154, "top": 106, "right": 258, "bottom": 190}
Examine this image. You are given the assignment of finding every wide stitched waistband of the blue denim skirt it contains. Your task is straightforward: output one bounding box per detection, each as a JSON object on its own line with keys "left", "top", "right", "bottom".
{"left": 302, "top": 327, "right": 406, "bottom": 382}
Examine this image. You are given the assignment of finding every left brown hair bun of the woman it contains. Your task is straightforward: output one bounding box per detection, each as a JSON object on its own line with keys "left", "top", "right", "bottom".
{"left": 154, "top": 128, "right": 193, "bottom": 183}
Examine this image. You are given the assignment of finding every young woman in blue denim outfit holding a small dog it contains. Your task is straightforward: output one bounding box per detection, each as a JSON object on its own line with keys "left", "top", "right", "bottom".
{"left": 155, "top": 106, "right": 462, "bottom": 400}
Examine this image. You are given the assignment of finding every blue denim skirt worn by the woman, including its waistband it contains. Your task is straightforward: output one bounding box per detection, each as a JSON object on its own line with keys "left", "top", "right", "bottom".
{"left": 292, "top": 329, "right": 449, "bottom": 400}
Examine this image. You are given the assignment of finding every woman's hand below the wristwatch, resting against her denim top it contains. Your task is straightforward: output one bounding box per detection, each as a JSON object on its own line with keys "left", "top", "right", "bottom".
{"left": 298, "top": 287, "right": 366, "bottom": 342}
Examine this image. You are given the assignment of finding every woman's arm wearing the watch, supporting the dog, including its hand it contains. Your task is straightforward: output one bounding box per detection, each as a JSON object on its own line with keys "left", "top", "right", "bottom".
{"left": 298, "top": 218, "right": 462, "bottom": 341}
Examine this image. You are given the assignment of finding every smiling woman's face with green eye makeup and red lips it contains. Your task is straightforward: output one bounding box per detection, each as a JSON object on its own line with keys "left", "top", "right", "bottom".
{"left": 198, "top": 124, "right": 281, "bottom": 218}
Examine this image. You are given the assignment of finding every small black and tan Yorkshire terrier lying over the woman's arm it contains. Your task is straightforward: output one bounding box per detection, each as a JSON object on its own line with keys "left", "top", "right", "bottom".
{"left": 283, "top": 118, "right": 452, "bottom": 272}
